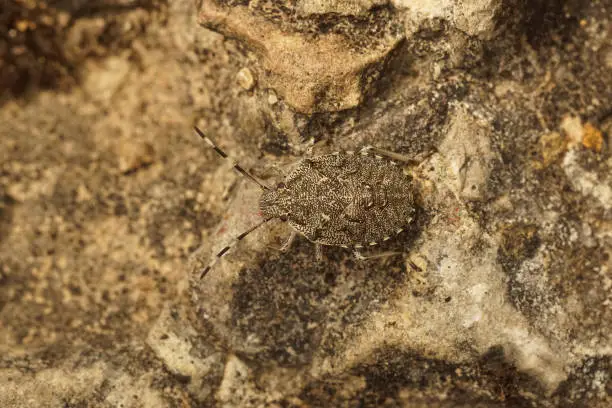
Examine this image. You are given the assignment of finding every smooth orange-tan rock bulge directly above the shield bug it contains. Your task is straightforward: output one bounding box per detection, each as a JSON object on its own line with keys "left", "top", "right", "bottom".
{"left": 199, "top": 1, "right": 401, "bottom": 114}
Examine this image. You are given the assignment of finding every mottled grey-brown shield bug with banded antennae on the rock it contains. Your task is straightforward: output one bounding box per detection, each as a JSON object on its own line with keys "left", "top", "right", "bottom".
{"left": 195, "top": 127, "right": 416, "bottom": 279}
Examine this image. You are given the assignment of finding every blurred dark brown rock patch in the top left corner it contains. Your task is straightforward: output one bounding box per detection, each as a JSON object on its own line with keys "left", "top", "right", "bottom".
{"left": 0, "top": 0, "right": 165, "bottom": 103}
